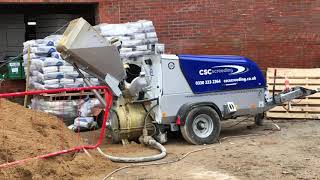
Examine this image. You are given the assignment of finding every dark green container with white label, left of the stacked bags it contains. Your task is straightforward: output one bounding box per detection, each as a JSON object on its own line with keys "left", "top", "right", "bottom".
{"left": 7, "top": 57, "right": 25, "bottom": 79}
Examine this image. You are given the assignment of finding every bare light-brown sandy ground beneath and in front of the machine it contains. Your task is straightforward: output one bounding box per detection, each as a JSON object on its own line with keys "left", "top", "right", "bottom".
{"left": 88, "top": 121, "right": 320, "bottom": 180}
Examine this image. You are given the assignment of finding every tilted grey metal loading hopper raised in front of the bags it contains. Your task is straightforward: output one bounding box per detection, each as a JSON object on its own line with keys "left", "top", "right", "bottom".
{"left": 57, "top": 18, "right": 126, "bottom": 96}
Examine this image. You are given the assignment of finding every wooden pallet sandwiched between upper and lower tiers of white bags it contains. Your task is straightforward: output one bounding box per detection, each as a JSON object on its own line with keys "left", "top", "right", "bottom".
{"left": 39, "top": 90, "right": 103, "bottom": 101}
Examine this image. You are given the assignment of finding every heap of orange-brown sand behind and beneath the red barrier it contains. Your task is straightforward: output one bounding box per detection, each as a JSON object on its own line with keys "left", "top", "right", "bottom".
{"left": 0, "top": 99, "right": 114, "bottom": 179}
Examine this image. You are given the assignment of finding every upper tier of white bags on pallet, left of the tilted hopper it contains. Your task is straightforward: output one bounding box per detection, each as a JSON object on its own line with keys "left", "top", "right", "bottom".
{"left": 23, "top": 35, "right": 99, "bottom": 89}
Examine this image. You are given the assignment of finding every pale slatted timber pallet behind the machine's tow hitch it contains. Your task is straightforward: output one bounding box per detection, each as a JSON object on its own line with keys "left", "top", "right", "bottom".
{"left": 267, "top": 68, "right": 320, "bottom": 119}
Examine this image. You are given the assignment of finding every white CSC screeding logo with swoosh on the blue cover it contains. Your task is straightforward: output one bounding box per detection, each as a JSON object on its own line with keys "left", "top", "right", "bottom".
{"left": 199, "top": 65, "right": 249, "bottom": 76}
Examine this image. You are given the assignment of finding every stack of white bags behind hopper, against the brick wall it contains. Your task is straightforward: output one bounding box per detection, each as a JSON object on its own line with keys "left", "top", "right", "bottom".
{"left": 95, "top": 20, "right": 159, "bottom": 61}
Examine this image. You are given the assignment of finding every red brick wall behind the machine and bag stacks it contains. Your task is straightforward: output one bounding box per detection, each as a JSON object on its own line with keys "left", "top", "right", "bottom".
{"left": 99, "top": 0, "right": 320, "bottom": 69}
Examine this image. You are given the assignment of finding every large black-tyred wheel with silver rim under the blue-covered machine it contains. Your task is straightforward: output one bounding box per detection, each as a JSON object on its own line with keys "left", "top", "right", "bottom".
{"left": 180, "top": 106, "right": 221, "bottom": 144}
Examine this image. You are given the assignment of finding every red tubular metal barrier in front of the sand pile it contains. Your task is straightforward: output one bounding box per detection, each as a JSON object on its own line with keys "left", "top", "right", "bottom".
{"left": 0, "top": 86, "right": 112, "bottom": 168}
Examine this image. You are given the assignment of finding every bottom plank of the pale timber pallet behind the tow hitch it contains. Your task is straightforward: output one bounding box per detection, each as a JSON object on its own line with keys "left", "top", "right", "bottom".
{"left": 267, "top": 112, "right": 320, "bottom": 119}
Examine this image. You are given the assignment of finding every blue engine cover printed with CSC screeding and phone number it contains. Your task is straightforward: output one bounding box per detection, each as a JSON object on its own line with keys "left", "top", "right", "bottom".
{"left": 178, "top": 55, "right": 266, "bottom": 94}
